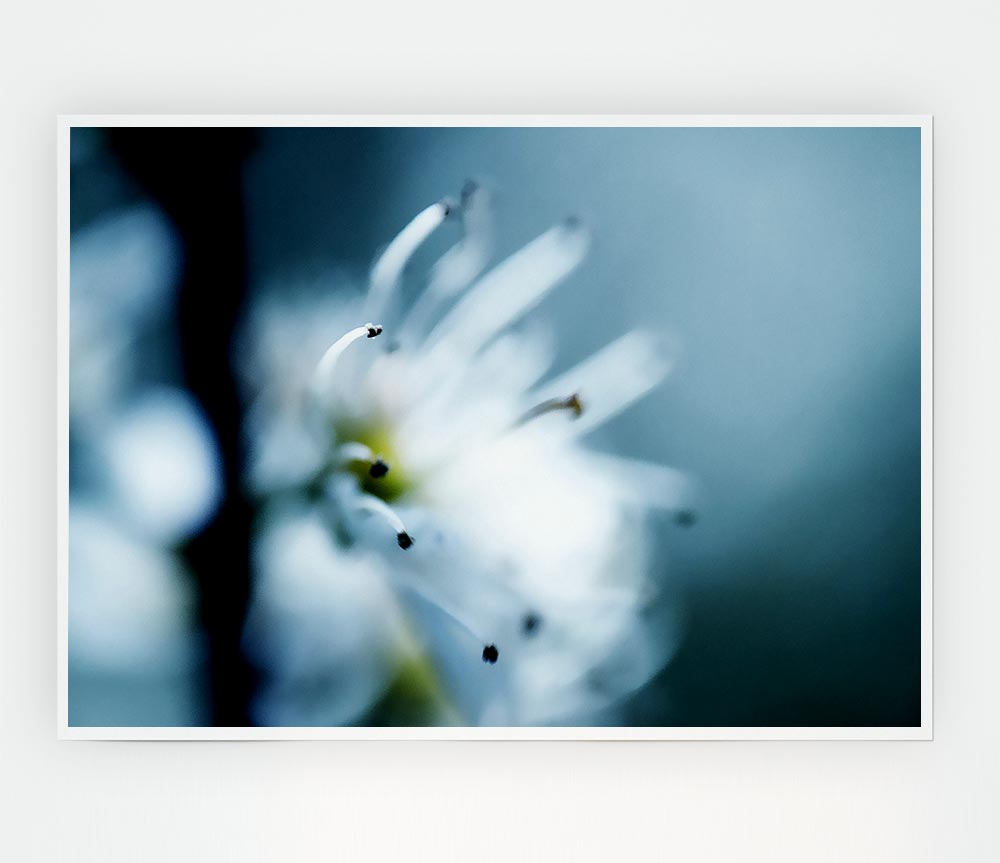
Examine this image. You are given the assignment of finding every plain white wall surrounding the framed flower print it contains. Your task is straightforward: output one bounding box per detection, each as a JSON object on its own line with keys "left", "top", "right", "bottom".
{"left": 0, "top": 0, "right": 1000, "bottom": 863}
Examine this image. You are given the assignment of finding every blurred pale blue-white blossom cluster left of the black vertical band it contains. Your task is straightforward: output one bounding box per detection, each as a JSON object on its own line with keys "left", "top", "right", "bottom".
{"left": 68, "top": 204, "right": 221, "bottom": 725}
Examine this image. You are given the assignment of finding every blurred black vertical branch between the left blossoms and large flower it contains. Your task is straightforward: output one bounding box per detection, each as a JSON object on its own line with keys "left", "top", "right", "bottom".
{"left": 112, "top": 129, "right": 253, "bottom": 725}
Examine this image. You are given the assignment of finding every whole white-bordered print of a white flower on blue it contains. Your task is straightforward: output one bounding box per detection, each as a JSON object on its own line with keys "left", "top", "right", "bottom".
{"left": 58, "top": 116, "right": 933, "bottom": 740}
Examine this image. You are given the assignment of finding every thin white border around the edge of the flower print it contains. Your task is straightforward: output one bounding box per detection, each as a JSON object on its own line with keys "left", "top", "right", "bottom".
{"left": 56, "top": 114, "right": 934, "bottom": 741}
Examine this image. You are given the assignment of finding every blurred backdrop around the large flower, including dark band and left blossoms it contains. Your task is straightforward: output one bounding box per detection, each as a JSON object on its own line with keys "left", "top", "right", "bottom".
{"left": 69, "top": 123, "right": 920, "bottom": 726}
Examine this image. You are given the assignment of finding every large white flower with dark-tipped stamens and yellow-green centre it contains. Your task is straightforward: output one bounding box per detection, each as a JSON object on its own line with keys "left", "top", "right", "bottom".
{"left": 245, "top": 186, "right": 685, "bottom": 725}
